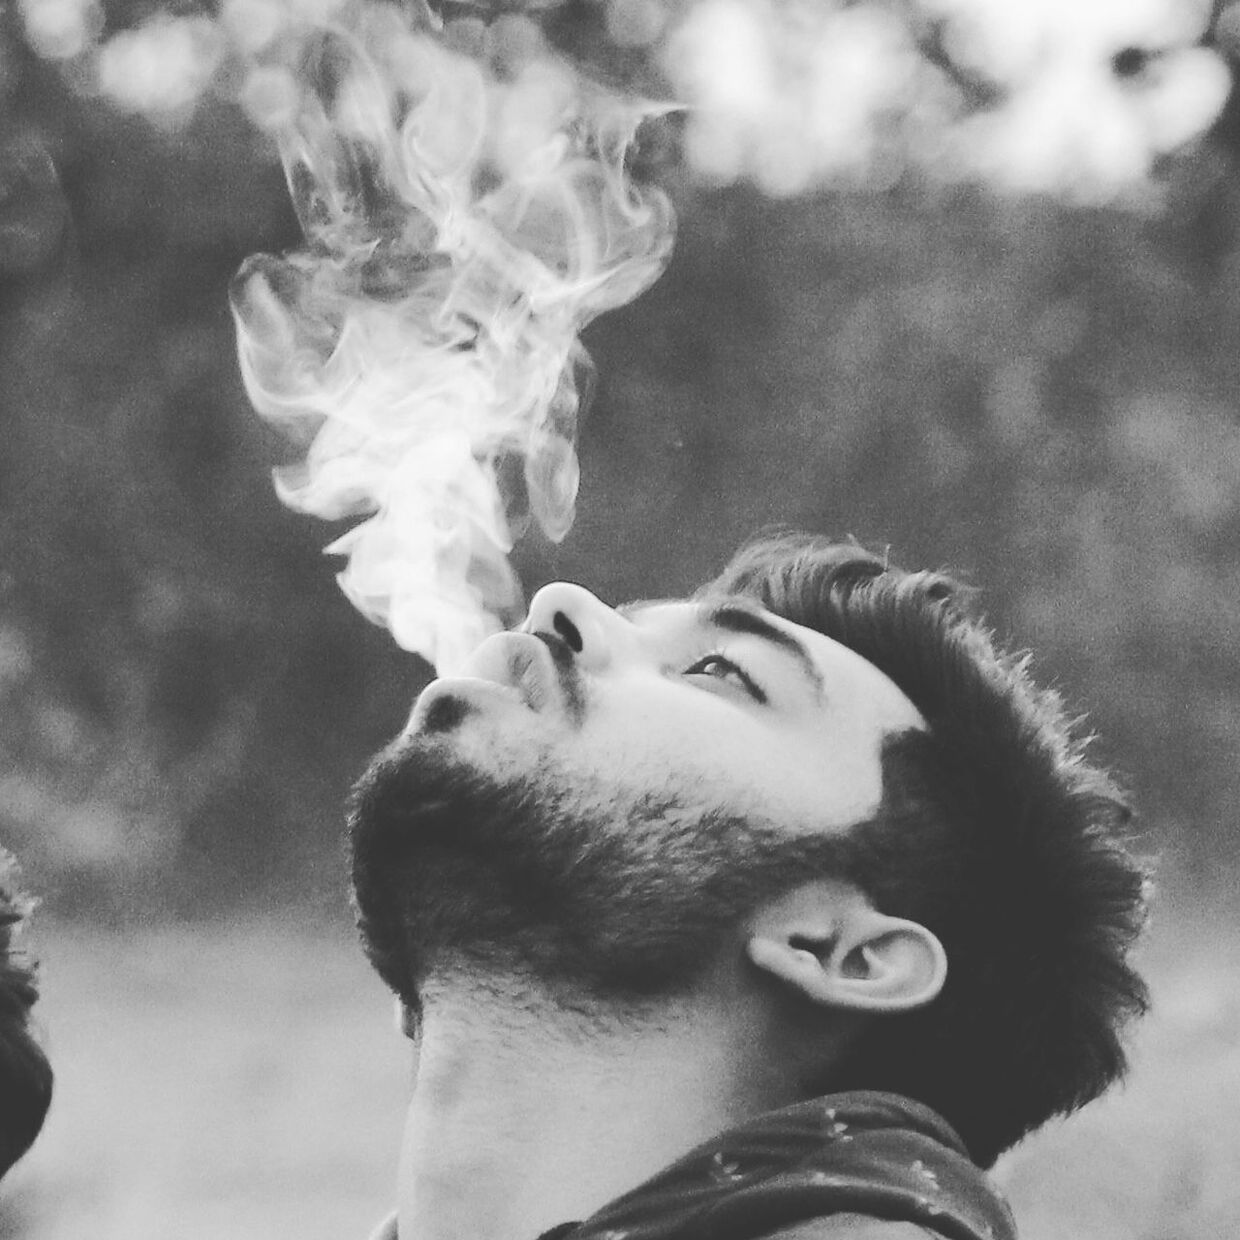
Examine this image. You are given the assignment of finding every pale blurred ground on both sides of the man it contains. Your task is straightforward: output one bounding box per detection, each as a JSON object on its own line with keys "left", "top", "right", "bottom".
{"left": 0, "top": 911, "right": 1240, "bottom": 1240}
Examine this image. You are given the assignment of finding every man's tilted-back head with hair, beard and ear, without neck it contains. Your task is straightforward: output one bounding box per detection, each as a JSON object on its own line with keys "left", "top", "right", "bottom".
{"left": 352, "top": 538, "right": 1145, "bottom": 1163}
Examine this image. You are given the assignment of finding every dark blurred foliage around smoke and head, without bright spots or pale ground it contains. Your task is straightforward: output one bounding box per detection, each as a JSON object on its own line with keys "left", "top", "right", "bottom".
{"left": 0, "top": 0, "right": 1240, "bottom": 910}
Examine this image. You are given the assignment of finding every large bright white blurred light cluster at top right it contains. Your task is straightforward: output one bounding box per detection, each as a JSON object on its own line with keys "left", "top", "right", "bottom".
{"left": 665, "top": 0, "right": 1230, "bottom": 201}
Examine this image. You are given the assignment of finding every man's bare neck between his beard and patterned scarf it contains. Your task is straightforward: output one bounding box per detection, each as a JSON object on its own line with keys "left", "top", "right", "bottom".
{"left": 399, "top": 978, "right": 794, "bottom": 1240}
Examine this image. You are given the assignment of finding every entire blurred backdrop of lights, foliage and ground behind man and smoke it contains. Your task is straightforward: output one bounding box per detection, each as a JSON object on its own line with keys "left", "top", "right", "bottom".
{"left": 0, "top": 0, "right": 1240, "bottom": 1240}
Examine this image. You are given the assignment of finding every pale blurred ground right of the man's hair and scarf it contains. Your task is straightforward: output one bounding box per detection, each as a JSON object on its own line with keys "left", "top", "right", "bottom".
{"left": 997, "top": 901, "right": 1240, "bottom": 1240}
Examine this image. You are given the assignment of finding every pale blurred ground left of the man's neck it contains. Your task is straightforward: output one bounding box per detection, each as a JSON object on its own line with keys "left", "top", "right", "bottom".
{"left": 0, "top": 918, "right": 407, "bottom": 1240}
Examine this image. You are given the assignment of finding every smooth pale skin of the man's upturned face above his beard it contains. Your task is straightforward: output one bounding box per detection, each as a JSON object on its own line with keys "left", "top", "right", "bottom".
{"left": 407, "top": 583, "right": 920, "bottom": 833}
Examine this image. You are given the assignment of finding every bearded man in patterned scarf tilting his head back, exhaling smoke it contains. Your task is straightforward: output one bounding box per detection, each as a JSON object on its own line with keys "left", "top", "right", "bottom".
{"left": 351, "top": 537, "right": 1146, "bottom": 1240}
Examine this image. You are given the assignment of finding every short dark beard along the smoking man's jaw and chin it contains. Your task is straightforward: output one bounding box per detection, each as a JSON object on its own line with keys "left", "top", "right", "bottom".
{"left": 350, "top": 734, "right": 852, "bottom": 1014}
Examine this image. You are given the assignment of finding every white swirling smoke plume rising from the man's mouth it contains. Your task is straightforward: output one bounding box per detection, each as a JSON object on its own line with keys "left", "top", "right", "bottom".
{"left": 232, "top": 9, "right": 672, "bottom": 672}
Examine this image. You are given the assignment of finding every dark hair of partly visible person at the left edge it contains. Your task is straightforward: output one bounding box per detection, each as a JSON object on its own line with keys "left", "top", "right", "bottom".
{"left": 0, "top": 848, "right": 52, "bottom": 1176}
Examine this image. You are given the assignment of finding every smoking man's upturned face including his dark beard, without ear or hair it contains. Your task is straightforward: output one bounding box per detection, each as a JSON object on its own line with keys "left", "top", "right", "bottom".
{"left": 353, "top": 584, "right": 923, "bottom": 992}
